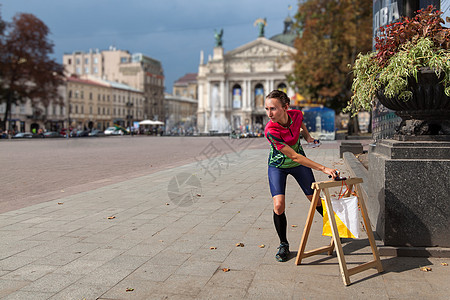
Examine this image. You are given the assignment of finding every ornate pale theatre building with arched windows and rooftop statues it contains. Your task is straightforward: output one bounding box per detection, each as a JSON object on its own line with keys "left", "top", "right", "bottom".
{"left": 197, "top": 23, "right": 295, "bottom": 133}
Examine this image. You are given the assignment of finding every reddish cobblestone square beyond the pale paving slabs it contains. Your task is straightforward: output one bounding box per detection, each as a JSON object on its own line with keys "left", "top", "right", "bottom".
{"left": 0, "top": 136, "right": 267, "bottom": 212}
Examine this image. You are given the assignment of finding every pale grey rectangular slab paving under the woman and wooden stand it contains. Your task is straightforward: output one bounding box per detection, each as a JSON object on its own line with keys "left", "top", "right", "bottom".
{"left": 0, "top": 140, "right": 450, "bottom": 300}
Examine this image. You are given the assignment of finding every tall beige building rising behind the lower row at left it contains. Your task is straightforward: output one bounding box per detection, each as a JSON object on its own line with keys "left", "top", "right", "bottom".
{"left": 63, "top": 47, "right": 165, "bottom": 121}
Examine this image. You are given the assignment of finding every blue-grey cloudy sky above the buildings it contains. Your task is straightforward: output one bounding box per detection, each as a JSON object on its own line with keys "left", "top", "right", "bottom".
{"left": 0, "top": 0, "right": 298, "bottom": 93}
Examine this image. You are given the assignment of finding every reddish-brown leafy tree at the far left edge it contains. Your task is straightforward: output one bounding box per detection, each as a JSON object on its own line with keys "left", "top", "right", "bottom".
{"left": 0, "top": 13, "right": 63, "bottom": 129}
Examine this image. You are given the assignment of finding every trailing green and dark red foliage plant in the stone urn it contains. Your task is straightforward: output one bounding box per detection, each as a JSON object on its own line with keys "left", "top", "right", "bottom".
{"left": 344, "top": 5, "right": 450, "bottom": 114}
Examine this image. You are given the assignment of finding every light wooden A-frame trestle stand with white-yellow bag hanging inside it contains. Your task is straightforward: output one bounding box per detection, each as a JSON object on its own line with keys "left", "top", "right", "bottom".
{"left": 295, "top": 178, "right": 383, "bottom": 285}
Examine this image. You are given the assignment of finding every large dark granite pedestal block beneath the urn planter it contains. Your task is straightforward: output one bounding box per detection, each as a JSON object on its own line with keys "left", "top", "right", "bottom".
{"left": 367, "top": 140, "right": 450, "bottom": 247}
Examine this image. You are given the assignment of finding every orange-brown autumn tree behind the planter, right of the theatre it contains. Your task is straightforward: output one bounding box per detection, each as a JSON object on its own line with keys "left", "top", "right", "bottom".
{"left": 288, "top": 0, "right": 373, "bottom": 110}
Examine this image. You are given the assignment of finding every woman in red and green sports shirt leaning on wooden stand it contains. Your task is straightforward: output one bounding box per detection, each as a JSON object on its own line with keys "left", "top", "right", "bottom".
{"left": 265, "top": 90, "right": 336, "bottom": 261}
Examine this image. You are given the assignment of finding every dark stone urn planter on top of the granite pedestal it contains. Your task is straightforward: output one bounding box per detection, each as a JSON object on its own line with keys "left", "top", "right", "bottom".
{"left": 377, "top": 69, "right": 450, "bottom": 136}
